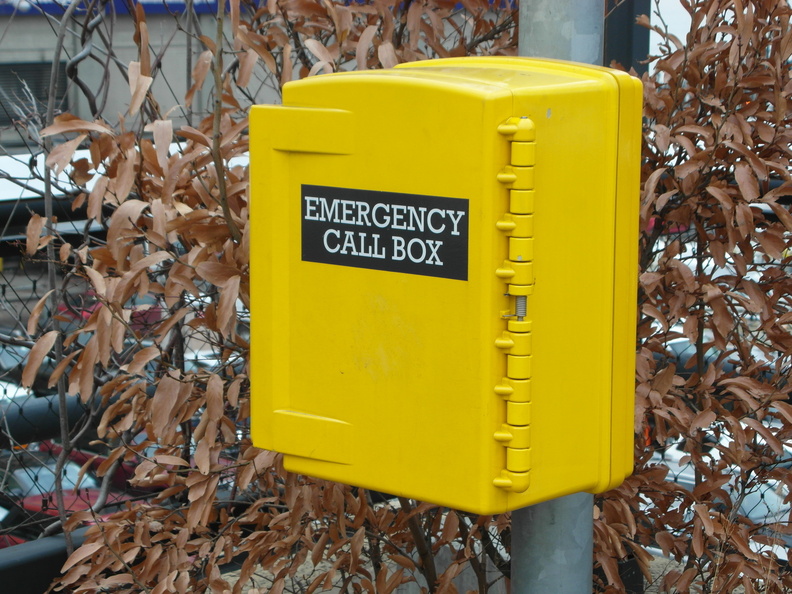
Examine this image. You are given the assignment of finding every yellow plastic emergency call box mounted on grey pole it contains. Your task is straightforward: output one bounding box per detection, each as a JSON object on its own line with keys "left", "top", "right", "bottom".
{"left": 250, "top": 57, "right": 641, "bottom": 514}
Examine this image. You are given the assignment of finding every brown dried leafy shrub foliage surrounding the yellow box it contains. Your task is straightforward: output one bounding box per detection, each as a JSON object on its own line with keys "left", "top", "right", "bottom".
{"left": 9, "top": 0, "right": 792, "bottom": 594}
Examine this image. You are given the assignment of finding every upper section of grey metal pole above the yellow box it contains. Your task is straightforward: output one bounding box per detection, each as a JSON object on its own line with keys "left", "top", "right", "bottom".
{"left": 519, "top": 0, "right": 605, "bottom": 64}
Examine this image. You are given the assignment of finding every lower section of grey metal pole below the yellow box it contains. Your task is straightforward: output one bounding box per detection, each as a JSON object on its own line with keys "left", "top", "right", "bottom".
{"left": 511, "top": 493, "right": 594, "bottom": 594}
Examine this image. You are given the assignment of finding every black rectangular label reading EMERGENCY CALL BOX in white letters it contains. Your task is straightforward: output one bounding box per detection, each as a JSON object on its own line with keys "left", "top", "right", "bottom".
{"left": 302, "top": 185, "right": 468, "bottom": 280}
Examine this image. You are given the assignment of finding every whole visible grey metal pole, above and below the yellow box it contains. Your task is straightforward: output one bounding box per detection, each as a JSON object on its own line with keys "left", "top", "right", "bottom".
{"left": 511, "top": 0, "right": 605, "bottom": 594}
